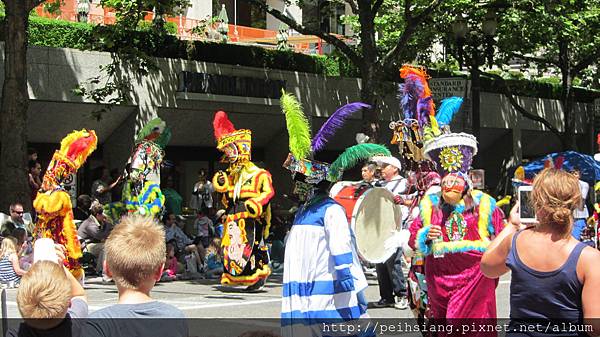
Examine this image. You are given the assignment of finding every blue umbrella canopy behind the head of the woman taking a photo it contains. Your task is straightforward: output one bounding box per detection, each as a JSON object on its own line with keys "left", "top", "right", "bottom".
{"left": 523, "top": 151, "right": 600, "bottom": 185}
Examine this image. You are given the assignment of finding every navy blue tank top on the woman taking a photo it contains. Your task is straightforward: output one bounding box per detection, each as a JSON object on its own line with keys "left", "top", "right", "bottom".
{"left": 506, "top": 231, "right": 587, "bottom": 336}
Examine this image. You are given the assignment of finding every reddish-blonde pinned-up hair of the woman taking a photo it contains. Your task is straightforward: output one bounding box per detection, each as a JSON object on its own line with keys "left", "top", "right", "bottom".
{"left": 531, "top": 168, "right": 582, "bottom": 233}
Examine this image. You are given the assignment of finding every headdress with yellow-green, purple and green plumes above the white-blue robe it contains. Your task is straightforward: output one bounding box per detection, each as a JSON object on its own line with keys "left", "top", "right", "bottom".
{"left": 280, "top": 91, "right": 382, "bottom": 183}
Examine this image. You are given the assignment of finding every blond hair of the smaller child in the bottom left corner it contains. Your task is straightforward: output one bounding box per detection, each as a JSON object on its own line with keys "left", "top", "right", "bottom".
{"left": 17, "top": 261, "right": 71, "bottom": 319}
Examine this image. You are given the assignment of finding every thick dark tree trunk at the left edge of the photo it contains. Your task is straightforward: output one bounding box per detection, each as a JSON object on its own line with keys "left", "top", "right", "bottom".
{"left": 0, "top": 0, "right": 31, "bottom": 211}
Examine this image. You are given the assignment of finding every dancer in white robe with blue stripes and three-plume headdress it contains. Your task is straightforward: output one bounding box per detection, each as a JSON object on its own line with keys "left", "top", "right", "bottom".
{"left": 281, "top": 93, "right": 382, "bottom": 336}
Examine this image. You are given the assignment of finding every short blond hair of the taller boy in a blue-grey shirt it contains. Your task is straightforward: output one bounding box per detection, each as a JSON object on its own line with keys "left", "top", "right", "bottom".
{"left": 104, "top": 215, "right": 166, "bottom": 289}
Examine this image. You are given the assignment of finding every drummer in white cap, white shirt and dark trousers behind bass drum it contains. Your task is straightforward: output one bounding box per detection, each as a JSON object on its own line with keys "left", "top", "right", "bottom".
{"left": 372, "top": 156, "right": 409, "bottom": 310}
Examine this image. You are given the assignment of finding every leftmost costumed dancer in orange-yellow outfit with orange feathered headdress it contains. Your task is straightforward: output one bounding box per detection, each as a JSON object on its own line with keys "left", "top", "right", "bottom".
{"left": 33, "top": 129, "right": 98, "bottom": 280}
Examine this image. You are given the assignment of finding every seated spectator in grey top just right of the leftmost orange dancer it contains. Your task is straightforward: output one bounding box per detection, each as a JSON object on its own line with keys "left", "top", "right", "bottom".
{"left": 77, "top": 201, "right": 112, "bottom": 279}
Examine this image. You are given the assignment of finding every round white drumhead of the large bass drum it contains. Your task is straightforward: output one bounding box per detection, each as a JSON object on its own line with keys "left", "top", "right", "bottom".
{"left": 352, "top": 187, "right": 402, "bottom": 263}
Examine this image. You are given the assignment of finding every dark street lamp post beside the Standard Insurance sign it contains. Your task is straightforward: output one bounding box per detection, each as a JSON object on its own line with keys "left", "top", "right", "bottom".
{"left": 452, "top": 8, "right": 498, "bottom": 144}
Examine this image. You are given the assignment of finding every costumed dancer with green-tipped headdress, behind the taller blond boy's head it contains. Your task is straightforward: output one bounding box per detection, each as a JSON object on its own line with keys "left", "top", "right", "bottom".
{"left": 105, "top": 118, "right": 171, "bottom": 223}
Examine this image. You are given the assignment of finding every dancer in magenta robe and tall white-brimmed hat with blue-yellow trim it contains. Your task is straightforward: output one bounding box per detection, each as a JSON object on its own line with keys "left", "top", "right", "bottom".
{"left": 409, "top": 100, "right": 504, "bottom": 326}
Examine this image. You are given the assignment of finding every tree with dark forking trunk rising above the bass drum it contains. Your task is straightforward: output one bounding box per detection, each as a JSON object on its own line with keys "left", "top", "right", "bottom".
{"left": 241, "top": 0, "right": 443, "bottom": 141}
